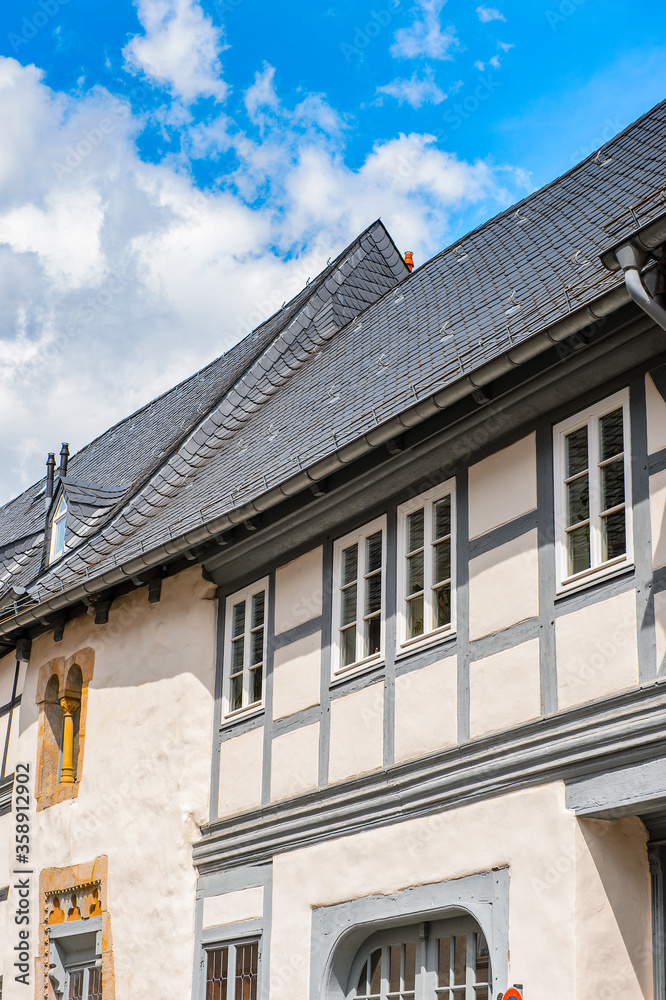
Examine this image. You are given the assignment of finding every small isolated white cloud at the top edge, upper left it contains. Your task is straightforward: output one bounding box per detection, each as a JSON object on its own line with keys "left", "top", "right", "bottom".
{"left": 123, "top": 0, "right": 229, "bottom": 104}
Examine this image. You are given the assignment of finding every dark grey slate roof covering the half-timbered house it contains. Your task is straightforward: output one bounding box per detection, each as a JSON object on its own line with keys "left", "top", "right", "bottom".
{"left": 0, "top": 102, "right": 666, "bottom": 616}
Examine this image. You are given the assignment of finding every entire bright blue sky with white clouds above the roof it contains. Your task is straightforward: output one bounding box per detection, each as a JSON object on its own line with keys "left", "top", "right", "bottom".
{"left": 0, "top": 0, "right": 666, "bottom": 501}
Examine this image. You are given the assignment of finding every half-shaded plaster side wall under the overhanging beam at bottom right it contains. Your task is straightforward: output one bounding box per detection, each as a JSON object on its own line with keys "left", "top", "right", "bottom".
{"left": 575, "top": 817, "right": 652, "bottom": 998}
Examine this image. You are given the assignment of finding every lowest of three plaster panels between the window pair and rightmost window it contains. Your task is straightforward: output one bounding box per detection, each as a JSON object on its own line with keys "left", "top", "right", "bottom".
{"left": 469, "top": 639, "right": 541, "bottom": 739}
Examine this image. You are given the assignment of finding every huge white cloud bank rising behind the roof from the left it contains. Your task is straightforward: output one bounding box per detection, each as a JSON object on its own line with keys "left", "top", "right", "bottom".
{"left": 0, "top": 58, "right": 522, "bottom": 498}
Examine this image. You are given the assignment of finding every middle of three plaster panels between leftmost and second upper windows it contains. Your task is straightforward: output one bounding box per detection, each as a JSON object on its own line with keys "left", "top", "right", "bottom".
{"left": 273, "top": 632, "right": 321, "bottom": 719}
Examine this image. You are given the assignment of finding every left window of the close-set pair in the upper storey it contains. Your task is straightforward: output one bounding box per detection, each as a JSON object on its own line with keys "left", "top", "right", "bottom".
{"left": 332, "top": 517, "right": 386, "bottom": 674}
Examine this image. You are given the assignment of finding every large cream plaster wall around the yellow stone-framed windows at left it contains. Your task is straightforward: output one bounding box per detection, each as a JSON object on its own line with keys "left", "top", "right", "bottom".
{"left": 5, "top": 567, "right": 216, "bottom": 1000}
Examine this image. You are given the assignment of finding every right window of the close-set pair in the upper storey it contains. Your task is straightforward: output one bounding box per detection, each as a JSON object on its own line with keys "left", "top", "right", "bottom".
{"left": 398, "top": 480, "right": 456, "bottom": 650}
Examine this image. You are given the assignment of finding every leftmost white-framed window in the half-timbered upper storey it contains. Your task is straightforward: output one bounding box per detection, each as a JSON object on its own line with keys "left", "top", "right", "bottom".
{"left": 223, "top": 577, "right": 268, "bottom": 717}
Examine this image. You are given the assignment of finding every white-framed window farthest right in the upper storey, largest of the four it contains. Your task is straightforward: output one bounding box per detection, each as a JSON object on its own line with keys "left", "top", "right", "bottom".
{"left": 554, "top": 390, "right": 633, "bottom": 592}
